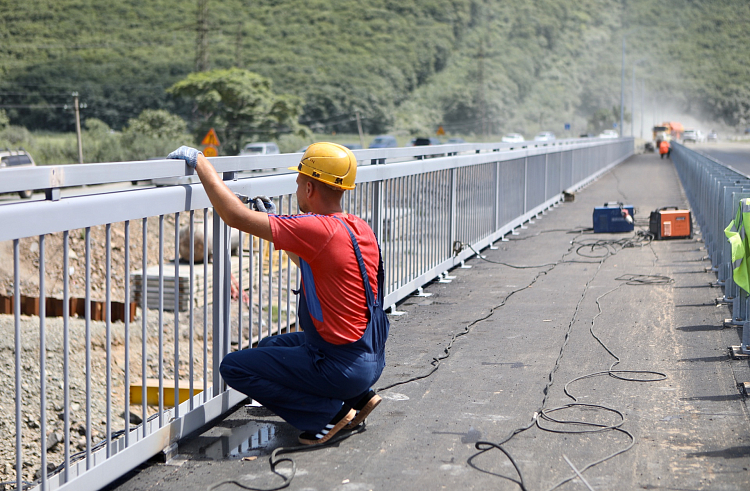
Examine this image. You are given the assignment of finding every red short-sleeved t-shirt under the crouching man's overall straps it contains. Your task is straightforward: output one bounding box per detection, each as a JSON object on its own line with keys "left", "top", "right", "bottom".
{"left": 268, "top": 213, "right": 379, "bottom": 345}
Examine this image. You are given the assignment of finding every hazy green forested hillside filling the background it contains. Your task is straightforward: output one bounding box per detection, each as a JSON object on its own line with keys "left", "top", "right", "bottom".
{"left": 0, "top": 0, "right": 750, "bottom": 141}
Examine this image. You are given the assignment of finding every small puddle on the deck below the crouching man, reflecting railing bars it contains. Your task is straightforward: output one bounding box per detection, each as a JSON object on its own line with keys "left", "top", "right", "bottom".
{"left": 201, "top": 421, "right": 278, "bottom": 460}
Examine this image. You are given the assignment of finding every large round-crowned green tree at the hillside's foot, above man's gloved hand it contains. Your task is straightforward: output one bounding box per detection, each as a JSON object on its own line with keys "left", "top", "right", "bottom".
{"left": 168, "top": 68, "right": 310, "bottom": 155}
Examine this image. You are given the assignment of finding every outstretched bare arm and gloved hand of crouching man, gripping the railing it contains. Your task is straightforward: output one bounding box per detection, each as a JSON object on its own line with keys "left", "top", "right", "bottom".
{"left": 167, "top": 146, "right": 273, "bottom": 245}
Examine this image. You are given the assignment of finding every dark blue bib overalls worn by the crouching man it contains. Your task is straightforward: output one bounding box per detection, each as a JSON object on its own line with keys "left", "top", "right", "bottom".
{"left": 219, "top": 217, "right": 389, "bottom": 432}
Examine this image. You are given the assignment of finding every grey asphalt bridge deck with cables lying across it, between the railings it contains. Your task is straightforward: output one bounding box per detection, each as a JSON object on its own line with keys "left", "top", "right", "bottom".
{"left": 104, "top": 155, "right": 750, "bottom": 491}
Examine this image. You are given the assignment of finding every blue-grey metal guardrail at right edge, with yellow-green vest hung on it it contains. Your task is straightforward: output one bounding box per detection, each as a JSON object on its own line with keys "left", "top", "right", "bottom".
{"left": 672, "top": 142, "right": 750, "bottom": 354}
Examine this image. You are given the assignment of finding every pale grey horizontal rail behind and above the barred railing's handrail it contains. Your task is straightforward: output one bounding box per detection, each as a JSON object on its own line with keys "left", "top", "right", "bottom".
{"left": 0, "top": 138, "right": 636, "bottom": 193}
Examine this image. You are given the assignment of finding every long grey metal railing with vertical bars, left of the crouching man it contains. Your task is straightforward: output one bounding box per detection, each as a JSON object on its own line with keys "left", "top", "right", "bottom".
{"left": 0, "top": 139, "right": 633, "bottom": 490}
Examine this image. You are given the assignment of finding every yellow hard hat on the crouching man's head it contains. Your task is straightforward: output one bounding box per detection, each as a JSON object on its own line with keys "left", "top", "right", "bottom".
{"left": 289, "top": 142, "right": 357, "bottom": 189}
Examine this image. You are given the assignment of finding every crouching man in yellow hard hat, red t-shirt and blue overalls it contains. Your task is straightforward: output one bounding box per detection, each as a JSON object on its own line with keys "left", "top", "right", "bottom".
{"left": 168, "top": 142, "right": 389, "bottom": 444}
